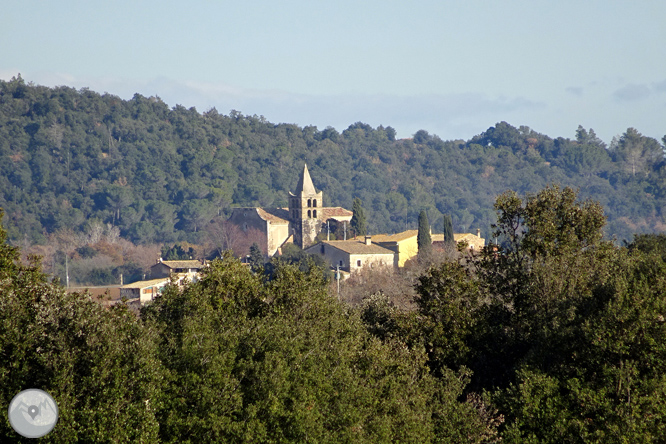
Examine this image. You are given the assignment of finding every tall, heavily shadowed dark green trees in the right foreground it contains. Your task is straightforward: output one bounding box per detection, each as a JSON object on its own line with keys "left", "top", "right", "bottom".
{"left": 364, "top": 187, "right": 666, "bottom": 444}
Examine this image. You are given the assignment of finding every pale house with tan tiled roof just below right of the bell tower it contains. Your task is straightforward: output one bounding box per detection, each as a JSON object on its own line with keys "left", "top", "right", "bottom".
{"left": 304, "top": 236, "right": 396, "bottom": 273}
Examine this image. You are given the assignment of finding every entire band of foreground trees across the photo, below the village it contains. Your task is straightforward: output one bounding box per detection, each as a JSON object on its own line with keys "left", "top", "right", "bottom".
{"left": 0, "top": 186, "right": 666, "bottom": 444}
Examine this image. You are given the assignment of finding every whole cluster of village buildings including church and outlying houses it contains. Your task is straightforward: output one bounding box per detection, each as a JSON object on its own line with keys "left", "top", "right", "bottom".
{"left": 98, "top": 165, "right": 485, "bottom": 306}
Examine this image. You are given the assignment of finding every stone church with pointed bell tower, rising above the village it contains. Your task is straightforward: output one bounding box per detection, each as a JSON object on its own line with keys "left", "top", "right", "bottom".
{"left": 229, "top": 165, "right": 353, "bottom": 256}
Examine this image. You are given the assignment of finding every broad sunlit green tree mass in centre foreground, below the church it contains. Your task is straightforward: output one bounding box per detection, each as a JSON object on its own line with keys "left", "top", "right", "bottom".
{"left": 142, "top": 255, "right": 496, "bottom": 443}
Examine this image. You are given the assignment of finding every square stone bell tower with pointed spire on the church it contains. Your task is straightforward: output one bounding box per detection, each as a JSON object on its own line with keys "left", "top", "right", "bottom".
{"left": 289, "top": 165, "right": 324, "bottom": 248}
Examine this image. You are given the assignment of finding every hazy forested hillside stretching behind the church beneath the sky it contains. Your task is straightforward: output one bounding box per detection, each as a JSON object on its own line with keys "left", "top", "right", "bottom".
{"left": 0, "top": 77, "right": 666, "bottom": 243}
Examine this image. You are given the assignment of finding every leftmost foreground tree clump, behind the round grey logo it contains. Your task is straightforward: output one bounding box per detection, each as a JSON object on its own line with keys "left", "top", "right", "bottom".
{"left": 0, "top": 210, "right": 163, "bottom": 443}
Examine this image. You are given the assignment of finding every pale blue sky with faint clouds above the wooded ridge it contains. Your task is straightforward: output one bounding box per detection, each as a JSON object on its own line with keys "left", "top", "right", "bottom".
{"left": 0, "top": 0, "right": 666, "bottom": 143}
